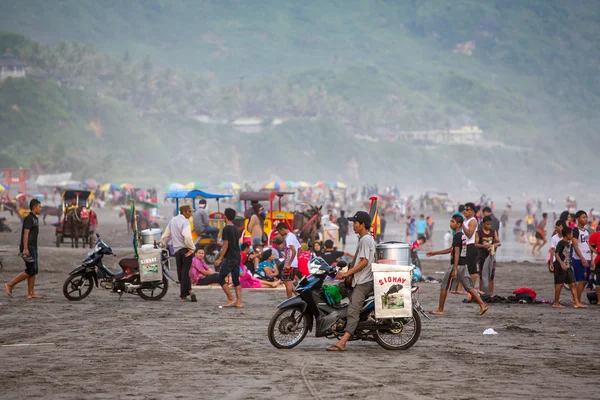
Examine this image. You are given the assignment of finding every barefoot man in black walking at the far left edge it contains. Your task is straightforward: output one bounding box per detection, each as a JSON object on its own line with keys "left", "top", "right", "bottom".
{"left": 5, "top": 199, "right": 42, "bottom": 299}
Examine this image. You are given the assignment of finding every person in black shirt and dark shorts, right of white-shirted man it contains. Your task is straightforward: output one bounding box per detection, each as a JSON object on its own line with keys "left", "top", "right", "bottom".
{"left": 215, "top": 208, "right": 243, "bottom": 308}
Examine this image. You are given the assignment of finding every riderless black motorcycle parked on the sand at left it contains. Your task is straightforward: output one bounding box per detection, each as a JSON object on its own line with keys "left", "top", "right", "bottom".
{"left": 63, "top": 234, "right": 175, "bottom": 301}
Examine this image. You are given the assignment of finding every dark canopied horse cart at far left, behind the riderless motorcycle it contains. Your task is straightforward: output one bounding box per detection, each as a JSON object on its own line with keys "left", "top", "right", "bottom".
{"left": 54, "top": 190, "right": 95, "bottom": 248}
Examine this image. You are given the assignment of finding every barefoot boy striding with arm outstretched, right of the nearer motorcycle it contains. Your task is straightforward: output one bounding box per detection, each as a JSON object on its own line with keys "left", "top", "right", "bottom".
{"left": 427, "top": 215, "right": 488, "bottom": 315}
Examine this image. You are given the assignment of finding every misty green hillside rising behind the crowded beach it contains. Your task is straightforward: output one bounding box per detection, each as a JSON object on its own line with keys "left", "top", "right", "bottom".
{"left": 0, "top": 0, "right": 600, "bottom": 196}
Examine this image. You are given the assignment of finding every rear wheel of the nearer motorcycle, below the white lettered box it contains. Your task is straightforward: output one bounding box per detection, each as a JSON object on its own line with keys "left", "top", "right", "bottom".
{"left": 376, "top": 310, "right": 421, "bottom": 350}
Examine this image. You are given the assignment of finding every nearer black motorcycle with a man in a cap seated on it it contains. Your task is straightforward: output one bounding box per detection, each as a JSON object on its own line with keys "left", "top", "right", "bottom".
{"left": 268, "top": 258, "right": 429, "bottom": 350}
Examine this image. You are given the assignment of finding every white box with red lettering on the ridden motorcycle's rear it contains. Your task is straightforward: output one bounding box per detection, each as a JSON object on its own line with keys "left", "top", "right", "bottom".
{"left": 372, "top": 264, "right": 412, "bottom": 318}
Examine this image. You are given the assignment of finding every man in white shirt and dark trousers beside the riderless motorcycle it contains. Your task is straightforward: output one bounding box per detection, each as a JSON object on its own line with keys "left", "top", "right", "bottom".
{"left": 160, "top": 204, "right": 195, "bottom": 301}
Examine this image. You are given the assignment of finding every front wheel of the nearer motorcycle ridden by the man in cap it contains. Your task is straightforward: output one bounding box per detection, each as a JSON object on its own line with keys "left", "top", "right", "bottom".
{"left": 269, "top": 308, "right": 309, "bottom": 349}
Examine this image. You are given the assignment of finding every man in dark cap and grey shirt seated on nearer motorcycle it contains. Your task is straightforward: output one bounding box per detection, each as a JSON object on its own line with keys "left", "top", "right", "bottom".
{"left": 327, "top": 211, "right": 375, "bottom": 351}
